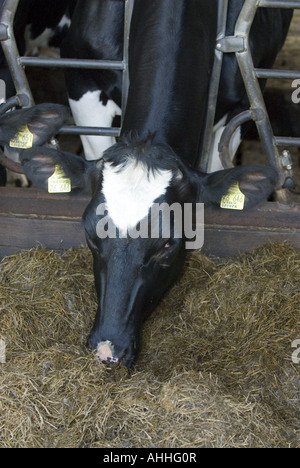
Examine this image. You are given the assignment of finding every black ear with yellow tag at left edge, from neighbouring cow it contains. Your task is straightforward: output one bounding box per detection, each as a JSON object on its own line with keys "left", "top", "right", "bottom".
{"left": 0, "top": 104, "right": 70, "bottom": 150}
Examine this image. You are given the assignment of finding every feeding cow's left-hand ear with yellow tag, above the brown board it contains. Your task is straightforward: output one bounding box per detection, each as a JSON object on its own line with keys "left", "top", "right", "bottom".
{"left": 21, "top": 147, "right": 94, "bottom": 194}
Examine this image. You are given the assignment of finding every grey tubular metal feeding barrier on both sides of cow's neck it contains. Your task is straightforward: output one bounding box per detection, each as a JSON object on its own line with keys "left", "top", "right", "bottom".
{"left": 0, "top": 0, "right": 300, "bottom": 203}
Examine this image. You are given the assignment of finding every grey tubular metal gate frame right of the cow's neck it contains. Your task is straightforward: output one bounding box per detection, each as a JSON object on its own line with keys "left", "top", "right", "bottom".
{"left": 200, "top": 0, "right": 300, "bottom": 203}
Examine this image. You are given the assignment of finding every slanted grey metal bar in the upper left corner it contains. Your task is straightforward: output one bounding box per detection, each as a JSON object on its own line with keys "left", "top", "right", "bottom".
{"left": 0, "top": 0, "right": 34, "bottom": 107}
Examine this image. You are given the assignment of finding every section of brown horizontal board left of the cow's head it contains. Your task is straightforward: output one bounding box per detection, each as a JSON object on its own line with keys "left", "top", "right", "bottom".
{"left": 0, "top": 187, "right": 89, "bottom": 258}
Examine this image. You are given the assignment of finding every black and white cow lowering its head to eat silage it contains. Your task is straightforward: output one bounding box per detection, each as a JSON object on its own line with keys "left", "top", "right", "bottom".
{"left": 2, "top": 0, "right": 278, "bottom": 367}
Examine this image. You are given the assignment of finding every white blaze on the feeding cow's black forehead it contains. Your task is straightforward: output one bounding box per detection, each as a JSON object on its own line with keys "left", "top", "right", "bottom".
{"left": 102, "top": 159, "right": 173, "bottom": 233}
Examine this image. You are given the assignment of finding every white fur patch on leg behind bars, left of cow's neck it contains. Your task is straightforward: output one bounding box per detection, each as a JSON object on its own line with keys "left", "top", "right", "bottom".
{"left": 69, "top": 91, "right": 121, "bottom": 161}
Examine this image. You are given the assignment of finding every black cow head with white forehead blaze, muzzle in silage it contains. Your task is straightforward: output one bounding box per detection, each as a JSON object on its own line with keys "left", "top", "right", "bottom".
{"left": 17, "top": 131, "right": 278, "bottom": 367}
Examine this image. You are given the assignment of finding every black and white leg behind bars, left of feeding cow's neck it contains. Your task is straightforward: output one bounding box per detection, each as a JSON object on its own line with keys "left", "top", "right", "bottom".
{"left": 61, "top": 0, "right": 124, "bottom": 160}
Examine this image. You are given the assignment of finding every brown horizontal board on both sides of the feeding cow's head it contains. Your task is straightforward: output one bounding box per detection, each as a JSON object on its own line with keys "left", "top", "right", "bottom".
{"left": 0, "top": 188, "right": 300, "bottom": 258}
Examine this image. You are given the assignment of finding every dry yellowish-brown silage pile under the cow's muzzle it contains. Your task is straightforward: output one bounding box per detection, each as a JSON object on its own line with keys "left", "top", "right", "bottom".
{"left": 0, "top": 244, "right": 300, "bottom": 448}
